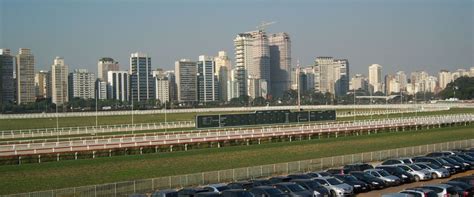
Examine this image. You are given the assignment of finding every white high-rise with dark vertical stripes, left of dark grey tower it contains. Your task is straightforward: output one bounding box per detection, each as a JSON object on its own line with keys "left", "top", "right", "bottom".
{"left": 107, "top": 71, "right": 130, "bottom": 101}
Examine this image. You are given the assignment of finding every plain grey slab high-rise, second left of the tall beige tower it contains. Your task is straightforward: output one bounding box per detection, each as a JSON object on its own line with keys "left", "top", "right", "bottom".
{"left": 174, "top": 59, "right": 198, "bottom": 104}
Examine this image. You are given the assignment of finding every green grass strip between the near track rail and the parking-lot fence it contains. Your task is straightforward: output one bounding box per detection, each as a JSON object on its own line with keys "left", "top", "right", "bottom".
{"left": 0, "top": 125, "right": 474, "bottom": 194}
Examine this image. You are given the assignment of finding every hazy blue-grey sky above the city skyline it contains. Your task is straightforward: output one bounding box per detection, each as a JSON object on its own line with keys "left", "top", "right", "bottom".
{"left": 0, "top": 0, "right": 474, "bottom": 75}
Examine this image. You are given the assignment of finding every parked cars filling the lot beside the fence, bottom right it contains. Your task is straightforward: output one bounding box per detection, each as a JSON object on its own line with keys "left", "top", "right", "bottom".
{"left": 133, "top": 148, "right": 474, "bottom": 197}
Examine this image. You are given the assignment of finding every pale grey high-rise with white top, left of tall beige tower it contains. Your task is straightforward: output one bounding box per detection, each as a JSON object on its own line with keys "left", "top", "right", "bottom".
{"left": 197, "top": 55, "right": 219, "bottom": 103}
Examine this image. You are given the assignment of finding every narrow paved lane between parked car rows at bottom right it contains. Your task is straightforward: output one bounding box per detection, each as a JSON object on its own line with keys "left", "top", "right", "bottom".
{"left": 357, "top": 170, "right": 474, "bottom": 197}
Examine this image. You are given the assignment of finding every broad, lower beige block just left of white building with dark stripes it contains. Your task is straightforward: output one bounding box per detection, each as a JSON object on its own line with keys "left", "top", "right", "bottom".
{"left": 68, "top": 69, "right": 96, "bottom": 99}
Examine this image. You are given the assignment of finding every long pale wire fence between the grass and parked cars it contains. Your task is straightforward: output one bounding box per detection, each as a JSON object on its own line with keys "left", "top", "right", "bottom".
{"left": 4, "top": 139, "right": 474, "bottom": 197}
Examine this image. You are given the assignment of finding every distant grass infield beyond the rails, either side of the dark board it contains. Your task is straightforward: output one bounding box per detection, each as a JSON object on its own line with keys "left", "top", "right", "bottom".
{"left": 0, "top": 108, "right": 474, "bottom": 130}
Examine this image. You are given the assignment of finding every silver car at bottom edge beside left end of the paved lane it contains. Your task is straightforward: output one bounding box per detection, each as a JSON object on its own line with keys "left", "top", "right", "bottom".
{"left": 313, "top": 177, "right": 354, "bottom": 196}
